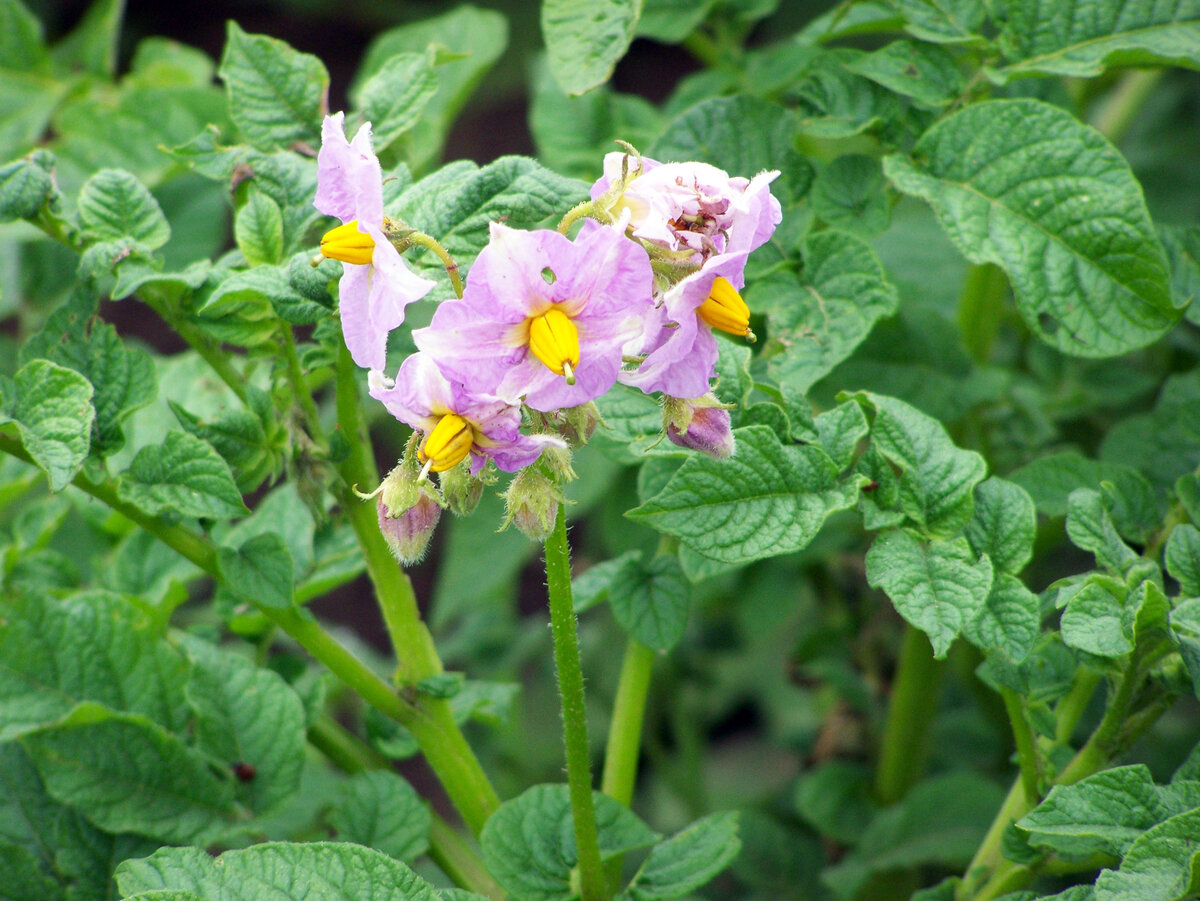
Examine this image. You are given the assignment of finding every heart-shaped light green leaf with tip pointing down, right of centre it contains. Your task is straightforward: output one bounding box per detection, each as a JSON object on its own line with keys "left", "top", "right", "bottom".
{"left": 866, "top": 529, "right": 992, "bottom": 659}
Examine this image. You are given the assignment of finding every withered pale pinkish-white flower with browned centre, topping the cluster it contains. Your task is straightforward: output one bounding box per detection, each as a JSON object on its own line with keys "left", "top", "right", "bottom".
{"left": 592, "top": 151, "right": 782, "bottom": 262}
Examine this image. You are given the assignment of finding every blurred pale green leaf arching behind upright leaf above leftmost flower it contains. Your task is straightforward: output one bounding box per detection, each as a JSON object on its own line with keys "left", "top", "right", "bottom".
{"left": 350, "top": 5, "right": 508, "bottom": 169}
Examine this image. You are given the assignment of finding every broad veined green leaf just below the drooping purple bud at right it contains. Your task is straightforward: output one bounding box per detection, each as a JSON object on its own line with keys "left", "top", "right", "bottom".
{"left": 626, "top": 426, "right": 858, "bottom": 563}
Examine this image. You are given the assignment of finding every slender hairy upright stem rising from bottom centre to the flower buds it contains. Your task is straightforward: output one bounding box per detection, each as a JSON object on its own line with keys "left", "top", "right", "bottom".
{"left": 546, "top": 504, "right": 608, "bottom": 901}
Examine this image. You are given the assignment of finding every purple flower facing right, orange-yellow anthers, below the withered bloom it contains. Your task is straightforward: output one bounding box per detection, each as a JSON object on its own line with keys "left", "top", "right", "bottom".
{"left": 620, "top": 251, "right": 752, "bottom": 397}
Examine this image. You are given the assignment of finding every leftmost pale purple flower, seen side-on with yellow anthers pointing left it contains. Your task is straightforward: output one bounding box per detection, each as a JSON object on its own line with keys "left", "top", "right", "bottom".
{"left": 313, "top": 113, "right": 436, "bottom": 370}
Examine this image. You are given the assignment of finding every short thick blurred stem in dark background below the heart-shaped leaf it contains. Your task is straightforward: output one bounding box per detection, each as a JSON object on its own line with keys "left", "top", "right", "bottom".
{"left": 875, "top": 625, "right": 943, "bottom": 805}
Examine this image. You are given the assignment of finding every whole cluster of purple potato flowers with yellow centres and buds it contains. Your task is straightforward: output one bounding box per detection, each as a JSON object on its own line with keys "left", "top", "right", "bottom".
{"left": 314, "top": 113, "right": 781, "bottom": 549}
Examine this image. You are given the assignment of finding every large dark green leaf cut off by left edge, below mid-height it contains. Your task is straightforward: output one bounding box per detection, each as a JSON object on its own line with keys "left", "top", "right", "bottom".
{"left": 0, "top": 591, "right": 187, "bottom": 740}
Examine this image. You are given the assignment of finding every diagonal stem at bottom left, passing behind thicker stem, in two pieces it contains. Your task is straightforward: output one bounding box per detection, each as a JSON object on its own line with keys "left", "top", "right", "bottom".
{"left": 308, "top": 716, "right": 506, "bottom": 901}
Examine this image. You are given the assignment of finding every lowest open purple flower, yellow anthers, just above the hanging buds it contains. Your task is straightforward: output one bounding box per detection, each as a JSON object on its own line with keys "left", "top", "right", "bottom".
{"left": 370, "top": 353, "right": 566, "bottom": 475}
